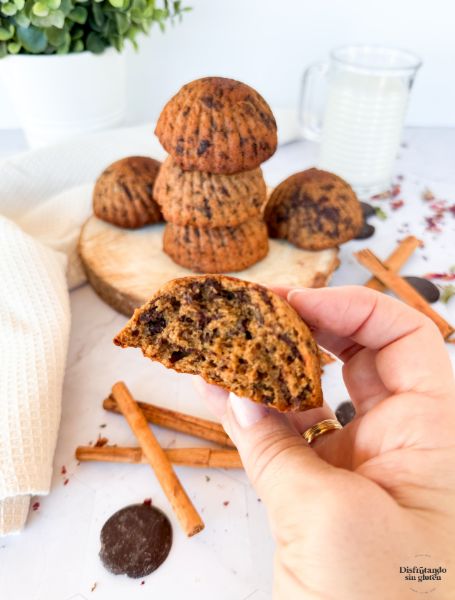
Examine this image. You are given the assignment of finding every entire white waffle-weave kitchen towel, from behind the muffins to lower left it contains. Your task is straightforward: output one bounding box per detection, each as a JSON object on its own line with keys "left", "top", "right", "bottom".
{"left": 0, "top": 125, "right": 163, "bottom": 535}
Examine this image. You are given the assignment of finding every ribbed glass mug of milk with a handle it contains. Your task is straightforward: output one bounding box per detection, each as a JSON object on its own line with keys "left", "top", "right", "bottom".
{"left": 300, "top": 46, "right": 421, "bottom": 197}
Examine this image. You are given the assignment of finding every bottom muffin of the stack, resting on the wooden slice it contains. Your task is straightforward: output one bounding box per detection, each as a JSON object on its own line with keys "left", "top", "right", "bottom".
{"left": 163, "top": 218, "right": 269, "bottom": 273}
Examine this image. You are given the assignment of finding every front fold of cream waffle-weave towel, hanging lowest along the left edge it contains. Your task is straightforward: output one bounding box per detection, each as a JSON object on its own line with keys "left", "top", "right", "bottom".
{"left": 0, "top": 217, "right": 70, "bottom": 534}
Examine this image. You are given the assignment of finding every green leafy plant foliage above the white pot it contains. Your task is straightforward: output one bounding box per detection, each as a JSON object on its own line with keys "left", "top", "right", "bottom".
{"left": 0, "top": 0, "right": 190, "bottom": 58}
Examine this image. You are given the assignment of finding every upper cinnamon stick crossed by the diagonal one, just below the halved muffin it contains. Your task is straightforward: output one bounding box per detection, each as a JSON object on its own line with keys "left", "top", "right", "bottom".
{"left": 103, "top": 394, "right": 235, "bottom": 448}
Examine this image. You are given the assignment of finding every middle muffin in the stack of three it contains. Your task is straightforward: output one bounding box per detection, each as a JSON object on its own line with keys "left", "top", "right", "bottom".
{"left": 154, "top": 156, "right": 267, "bottom": 227}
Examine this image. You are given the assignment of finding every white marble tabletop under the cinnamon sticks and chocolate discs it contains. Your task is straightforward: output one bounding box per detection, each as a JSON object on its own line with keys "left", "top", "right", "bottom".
{"left": 0, "top": 130, "right": 455, "bottom": 600}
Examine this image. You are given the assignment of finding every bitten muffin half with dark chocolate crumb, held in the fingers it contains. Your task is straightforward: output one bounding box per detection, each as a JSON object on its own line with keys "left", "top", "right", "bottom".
{"left": 114, "top": 275, "right": 322, "bottom": 411}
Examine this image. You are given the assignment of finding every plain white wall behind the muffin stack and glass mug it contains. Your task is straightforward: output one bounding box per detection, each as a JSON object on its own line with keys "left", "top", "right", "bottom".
{"left": 0, "top": 0, "right": 455, "bottom": 128}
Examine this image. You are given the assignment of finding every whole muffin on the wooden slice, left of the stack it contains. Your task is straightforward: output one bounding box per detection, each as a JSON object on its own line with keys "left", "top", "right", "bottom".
{"left": 93, "top": 156, "right": 163, "bottom": 229}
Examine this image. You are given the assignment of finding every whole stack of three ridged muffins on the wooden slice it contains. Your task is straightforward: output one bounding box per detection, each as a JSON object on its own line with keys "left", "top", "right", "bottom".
{"left": 154, "top": 77, "right": 277, "bottom": 273}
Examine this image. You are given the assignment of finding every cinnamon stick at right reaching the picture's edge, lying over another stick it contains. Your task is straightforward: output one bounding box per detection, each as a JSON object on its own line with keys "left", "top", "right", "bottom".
{"left": 355, "top": 249, "right": 455, "bottom": 339}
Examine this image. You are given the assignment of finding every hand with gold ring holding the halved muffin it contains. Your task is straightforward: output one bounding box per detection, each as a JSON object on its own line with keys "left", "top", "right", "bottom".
{"left": 197, "top": 287, "right": 455, "bottom": 600}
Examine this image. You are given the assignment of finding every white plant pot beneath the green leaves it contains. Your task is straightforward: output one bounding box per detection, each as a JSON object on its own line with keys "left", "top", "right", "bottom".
{"left": 0, "top": 48, "right": 126, "bottom": 148}
